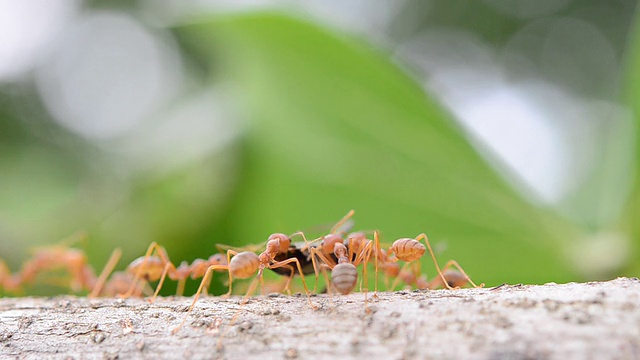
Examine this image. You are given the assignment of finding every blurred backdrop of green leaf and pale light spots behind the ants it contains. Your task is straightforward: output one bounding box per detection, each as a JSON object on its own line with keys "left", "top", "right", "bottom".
{"left": 0, "top": 0, "right": 640, "bottom": 294}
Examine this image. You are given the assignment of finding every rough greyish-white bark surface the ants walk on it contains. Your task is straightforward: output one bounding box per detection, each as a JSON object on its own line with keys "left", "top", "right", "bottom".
{"left": 0, "top": 278, "right": 640, "bottom": 359}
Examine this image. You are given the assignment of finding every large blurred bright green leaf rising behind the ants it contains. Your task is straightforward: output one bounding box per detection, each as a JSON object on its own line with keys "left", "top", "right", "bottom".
{"left": 179, "top": 14, "right": 576, "bottom": 284}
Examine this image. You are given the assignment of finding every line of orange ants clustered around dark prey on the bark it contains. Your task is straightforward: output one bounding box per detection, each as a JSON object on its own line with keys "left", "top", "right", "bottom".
{"left": 0, "top": 210, "right": 484, "bottom": 332}
